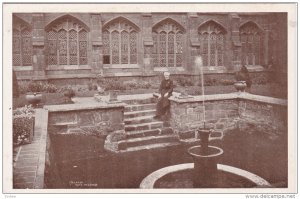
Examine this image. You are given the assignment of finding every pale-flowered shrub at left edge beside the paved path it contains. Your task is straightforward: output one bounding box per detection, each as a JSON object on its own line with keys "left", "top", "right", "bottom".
{"left": 13, "top": 105, "right": 35, "bottom": 145}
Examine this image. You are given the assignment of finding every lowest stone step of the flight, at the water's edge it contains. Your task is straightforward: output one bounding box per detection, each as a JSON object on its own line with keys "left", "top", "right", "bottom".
{"left": 118, "top": 134, "right": 179, "bottom": 150}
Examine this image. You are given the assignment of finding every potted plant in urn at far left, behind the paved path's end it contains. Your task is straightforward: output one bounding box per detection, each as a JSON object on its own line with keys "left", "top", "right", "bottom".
{"left": 25, "top": 80, "right": 43, "bottom": 107}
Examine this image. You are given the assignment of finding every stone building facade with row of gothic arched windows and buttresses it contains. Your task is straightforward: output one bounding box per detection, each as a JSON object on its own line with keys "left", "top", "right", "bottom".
{"left": 12, "top": 13, "right": 287, "bottom": 84}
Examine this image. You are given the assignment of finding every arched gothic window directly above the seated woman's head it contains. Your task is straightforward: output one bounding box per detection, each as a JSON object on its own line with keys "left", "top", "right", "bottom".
{"left": 152, "top": 20, "right": 184, "bottom": 67}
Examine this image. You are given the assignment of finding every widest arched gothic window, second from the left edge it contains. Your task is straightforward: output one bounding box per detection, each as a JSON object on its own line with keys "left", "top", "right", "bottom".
{"left": 47, "top": 17, "right": 88, "bottom": 66}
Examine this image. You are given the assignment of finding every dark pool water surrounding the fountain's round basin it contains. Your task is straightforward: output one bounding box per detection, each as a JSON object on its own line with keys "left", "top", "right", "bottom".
{"left": 46, "top": 127, "right": 287, "bottom": 188}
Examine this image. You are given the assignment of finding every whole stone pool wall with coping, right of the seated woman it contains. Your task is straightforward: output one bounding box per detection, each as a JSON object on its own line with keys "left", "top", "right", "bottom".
{"left": 171, "top": 93, "right": 287, "bottom": 135}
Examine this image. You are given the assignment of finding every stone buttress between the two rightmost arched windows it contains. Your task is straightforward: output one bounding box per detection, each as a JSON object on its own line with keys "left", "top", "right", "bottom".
{"left": 228, "top": 13, "right": 242, "bottom": 70}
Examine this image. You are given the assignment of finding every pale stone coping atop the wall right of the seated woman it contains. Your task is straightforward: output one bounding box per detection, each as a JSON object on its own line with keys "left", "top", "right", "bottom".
{"left": 170, "top": 92, "right": 287, "bottom": 106}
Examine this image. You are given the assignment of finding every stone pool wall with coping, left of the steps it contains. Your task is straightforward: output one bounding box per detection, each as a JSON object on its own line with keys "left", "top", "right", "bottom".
{"left": 46, "top": 103, "right": 124, "bottom": 136}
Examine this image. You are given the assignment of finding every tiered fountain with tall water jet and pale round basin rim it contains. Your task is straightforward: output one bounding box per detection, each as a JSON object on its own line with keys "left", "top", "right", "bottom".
{"left": 140, "top": 56, "right": 270, "bottom": 188}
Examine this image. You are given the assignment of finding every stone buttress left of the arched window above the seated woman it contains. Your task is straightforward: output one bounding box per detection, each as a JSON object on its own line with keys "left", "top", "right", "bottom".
{"left": 142, "top": 13, "right": 153, "bottom": 74}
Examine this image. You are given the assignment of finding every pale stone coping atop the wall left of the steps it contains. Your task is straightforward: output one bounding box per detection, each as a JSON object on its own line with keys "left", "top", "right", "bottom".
{"left": 44, "top": 102, "right": 126, "bottom": 112}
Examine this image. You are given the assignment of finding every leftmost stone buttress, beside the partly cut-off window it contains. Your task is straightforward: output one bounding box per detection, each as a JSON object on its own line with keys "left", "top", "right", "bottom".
{"left": 32, "top": 13, "right": 47, "bottom": 79}
